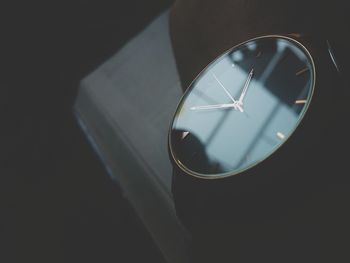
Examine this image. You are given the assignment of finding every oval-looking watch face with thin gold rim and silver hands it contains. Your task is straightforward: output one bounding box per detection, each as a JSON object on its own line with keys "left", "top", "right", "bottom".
{"left": 169, "top": 36, "right": 315, "bottom": 178}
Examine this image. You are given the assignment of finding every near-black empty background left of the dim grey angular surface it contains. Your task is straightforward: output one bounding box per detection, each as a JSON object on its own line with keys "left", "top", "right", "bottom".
{"left": 0, "top": 0, "right": 171, "bottom": 262}
